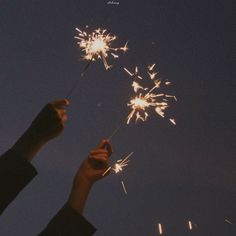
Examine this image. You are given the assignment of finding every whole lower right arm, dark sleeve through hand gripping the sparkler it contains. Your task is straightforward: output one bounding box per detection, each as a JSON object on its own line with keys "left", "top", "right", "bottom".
{"left": 40, "top": 140, "right": 112, "bottom": 236}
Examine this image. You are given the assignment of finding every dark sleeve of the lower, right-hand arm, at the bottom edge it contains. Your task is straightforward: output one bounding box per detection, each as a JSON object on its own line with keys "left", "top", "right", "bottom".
{"left": 39, "top": 204, "right": 96, "bottom": 236}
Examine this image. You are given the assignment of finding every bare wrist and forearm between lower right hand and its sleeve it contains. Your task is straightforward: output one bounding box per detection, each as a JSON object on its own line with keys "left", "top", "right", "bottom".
{"left": 68, "top": 179, "right": 92, "bottom": 215}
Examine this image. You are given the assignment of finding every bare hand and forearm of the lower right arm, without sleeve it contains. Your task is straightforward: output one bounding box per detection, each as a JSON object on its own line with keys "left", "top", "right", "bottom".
{"left": 68, "top": 140, "right": 112, "bottom": 214}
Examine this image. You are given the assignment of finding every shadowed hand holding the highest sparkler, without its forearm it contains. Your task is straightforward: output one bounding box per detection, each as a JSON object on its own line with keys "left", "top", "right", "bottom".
{"left": 27, "top": 99, "right": 69, "bottom": 143}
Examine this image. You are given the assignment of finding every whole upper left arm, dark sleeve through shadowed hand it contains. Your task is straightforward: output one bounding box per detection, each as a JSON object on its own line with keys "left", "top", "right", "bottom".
{"left": 0, "top": 100, "right": 68, "bottom": 214}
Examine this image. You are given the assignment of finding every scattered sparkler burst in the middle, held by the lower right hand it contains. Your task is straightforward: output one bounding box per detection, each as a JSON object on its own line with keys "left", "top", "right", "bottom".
{"left": 124, "top": 64, "right": 177, "bottom": 125}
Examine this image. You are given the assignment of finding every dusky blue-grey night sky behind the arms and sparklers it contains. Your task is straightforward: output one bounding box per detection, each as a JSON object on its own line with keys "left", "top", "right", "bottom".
{"left": 0, "top": 0, "right": 236, "bottom": 236}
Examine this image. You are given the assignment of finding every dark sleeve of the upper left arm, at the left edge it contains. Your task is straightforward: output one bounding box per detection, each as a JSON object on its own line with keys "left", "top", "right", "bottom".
{"left": 0, "top": 149, "right": 37, "bottom": 215}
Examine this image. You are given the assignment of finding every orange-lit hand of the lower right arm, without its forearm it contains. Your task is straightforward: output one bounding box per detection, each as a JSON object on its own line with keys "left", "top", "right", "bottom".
{"left": 74, "top": 140, "right": 112, "bottom": 185}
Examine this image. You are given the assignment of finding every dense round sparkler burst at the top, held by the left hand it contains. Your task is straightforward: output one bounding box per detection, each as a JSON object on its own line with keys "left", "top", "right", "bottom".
{"left": 74, "top": 28, "right": 128, "bottom": 70}
